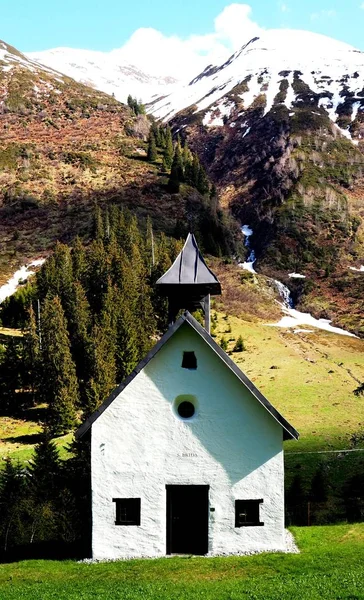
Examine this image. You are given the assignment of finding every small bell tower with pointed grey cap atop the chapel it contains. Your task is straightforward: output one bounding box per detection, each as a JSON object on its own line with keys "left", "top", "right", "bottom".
{"left": 156, "top": 233, "right": 221, "bottom": 333}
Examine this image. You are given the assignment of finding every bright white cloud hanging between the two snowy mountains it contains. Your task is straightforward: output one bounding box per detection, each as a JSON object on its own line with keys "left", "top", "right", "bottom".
{"left": 111, "top": 3, "right": 263, "bottom": 79}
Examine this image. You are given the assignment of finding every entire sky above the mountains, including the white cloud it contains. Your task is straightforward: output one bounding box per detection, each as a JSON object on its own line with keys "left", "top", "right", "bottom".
{"left": 0, "top": 0, "right": 364, "bottom": 73}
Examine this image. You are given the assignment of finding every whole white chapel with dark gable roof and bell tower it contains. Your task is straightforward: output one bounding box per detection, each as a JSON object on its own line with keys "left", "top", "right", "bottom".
{"left": 76, "top": 234, "right": 298, "bottom": 559}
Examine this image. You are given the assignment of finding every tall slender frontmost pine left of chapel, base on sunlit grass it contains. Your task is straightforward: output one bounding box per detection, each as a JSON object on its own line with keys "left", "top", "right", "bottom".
{"left": 40, "top": 296, "right": 79, "bottom": 435}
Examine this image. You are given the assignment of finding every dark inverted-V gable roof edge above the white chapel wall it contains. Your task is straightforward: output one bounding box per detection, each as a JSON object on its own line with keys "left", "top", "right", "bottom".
{"left": 75, "top": 312, "right": 299, "bottom": 440}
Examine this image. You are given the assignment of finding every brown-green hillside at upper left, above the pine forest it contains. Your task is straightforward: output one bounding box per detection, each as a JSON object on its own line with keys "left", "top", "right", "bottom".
{"left": 0, "top": 42, "right": 236, "bottom": 283}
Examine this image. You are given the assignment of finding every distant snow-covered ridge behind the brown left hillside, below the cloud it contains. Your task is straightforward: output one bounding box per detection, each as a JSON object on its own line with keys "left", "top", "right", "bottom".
{"left": 27, "top": 48, "right": 177, "bottom": 102}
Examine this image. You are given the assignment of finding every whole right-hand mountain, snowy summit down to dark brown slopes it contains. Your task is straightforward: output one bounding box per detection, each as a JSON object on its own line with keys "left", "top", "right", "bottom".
{"left": 148, "top": 30, "right": 364, "bottom": 334}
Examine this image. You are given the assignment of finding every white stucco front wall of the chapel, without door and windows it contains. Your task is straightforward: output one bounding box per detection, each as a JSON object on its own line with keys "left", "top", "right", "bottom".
{"left": 91, "top": 323, "right": 284, "bottom": 558}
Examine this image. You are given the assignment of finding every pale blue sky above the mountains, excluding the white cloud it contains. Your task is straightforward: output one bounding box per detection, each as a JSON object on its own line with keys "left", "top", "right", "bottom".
{"left": 0, "top": 0, "right": 364, "bottom": 52}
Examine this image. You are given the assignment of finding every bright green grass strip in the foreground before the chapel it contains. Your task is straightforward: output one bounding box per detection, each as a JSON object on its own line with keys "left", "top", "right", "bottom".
{"left": 0, "top": 524, "right": 364, "bottom": 600}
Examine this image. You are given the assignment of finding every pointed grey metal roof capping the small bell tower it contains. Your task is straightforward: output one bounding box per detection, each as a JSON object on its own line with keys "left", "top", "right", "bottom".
{"left": 157, "top": 233, "right": 221, "bottom": 294}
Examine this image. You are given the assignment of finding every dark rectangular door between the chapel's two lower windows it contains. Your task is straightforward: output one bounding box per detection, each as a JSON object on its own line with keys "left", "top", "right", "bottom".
{"left": 166, "top": 485, "right": 209, "bottom": 554}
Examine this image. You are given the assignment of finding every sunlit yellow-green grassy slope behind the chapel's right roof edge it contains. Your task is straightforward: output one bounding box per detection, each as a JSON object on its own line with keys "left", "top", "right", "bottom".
{"left": 215, "top": 267, "right": 364, "bottom": 452}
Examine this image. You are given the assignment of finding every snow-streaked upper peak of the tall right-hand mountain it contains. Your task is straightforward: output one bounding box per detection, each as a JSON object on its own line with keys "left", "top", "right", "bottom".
{"left": 150, "top": 30, "right": 364, "bottom": 137}
